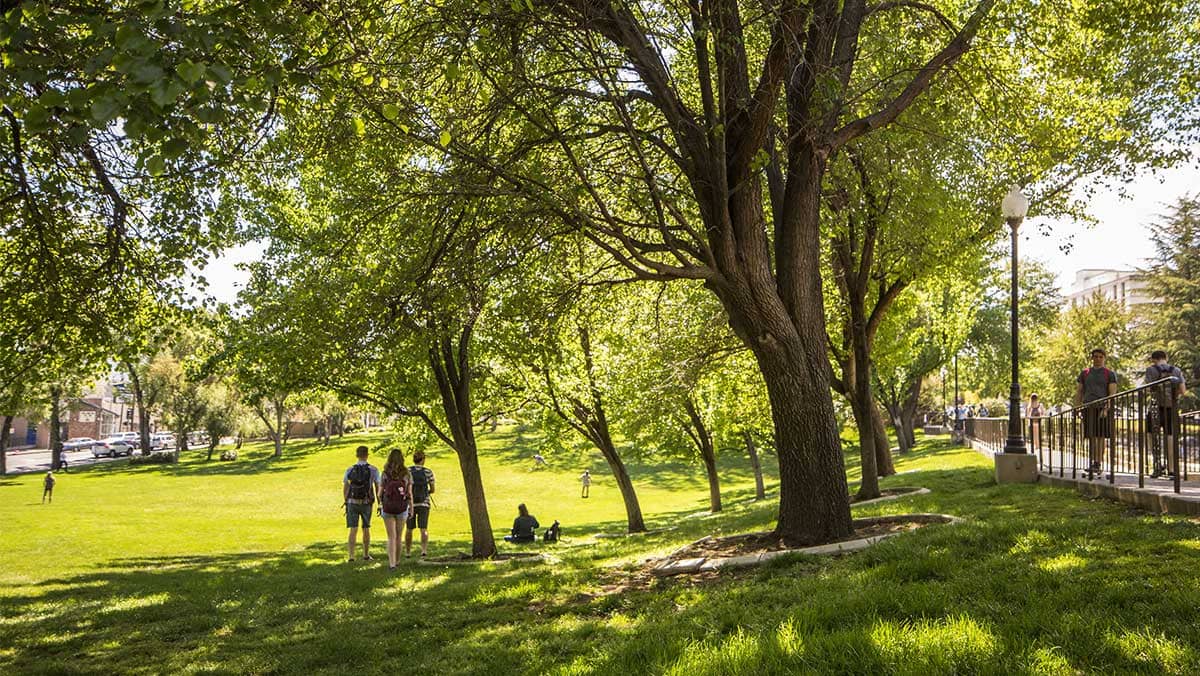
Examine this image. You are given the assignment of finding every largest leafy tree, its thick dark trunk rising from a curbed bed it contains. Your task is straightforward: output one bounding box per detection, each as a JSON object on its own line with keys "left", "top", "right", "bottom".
{"left": 309, "top": 0, "right": 1195, "bottom": 543}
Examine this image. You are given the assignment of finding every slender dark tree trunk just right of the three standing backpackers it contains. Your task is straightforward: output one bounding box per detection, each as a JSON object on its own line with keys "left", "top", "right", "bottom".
{"left": 430, "top": 331, "right": 496, "bottom": 558}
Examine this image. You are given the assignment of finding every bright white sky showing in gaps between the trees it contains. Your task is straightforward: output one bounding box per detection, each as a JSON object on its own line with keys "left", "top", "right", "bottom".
{"left": 196, "top": 162, "right": 1200, "bottom": 304}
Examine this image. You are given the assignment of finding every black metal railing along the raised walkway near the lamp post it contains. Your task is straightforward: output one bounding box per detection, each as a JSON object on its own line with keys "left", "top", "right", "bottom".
{"left": 966, "top": 378, "right": 1185, "bottom": 492}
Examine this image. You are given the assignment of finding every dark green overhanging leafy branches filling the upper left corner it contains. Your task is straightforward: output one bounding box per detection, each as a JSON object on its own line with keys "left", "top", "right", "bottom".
{"left": 0, "top": 0, "right": 322, "bottom": 391}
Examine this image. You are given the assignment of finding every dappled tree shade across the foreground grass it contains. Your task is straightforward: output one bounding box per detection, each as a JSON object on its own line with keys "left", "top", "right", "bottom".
{"left": 0, "top": 491, "right": 1200, "bottom": 674}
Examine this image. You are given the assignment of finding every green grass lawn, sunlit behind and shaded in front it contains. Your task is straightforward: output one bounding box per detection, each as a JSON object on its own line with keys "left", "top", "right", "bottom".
{"left": 0, "top": 430, "right": 1200, "bottom": 676}
